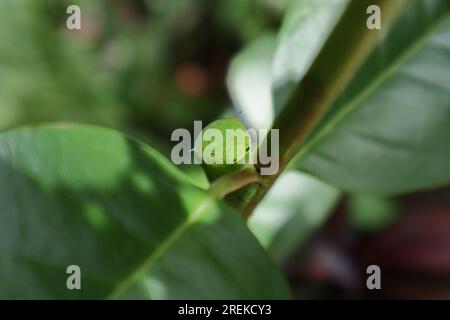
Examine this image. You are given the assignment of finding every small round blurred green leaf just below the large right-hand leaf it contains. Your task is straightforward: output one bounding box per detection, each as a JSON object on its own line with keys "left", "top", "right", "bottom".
{"left": 348, "top": 195, "right": 400, "bottom": 232}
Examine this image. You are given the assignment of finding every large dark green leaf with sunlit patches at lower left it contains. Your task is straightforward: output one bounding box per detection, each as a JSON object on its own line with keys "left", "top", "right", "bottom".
{"left": 0, "top": 126, "right": 289, "bottom": 299}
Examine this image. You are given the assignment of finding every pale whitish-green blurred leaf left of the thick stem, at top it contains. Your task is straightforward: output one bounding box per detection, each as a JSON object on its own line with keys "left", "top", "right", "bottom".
{"left": 227, "top": 0, "right": 348, "bottom": 128}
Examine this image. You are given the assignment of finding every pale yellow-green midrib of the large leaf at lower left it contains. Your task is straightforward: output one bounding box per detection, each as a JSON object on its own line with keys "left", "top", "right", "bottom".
{"left": 107, "top": 194, "right": 216, "bottom": 299}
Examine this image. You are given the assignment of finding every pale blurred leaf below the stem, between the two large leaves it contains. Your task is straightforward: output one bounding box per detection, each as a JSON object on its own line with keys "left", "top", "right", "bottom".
{"left": 249, "top": 171, "right": 339, "bottom": 262}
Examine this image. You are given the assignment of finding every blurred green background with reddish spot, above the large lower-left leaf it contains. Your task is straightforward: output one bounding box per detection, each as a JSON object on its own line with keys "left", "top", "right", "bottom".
{"left": 0, "top": 0, "right": 285, "bottom": 147}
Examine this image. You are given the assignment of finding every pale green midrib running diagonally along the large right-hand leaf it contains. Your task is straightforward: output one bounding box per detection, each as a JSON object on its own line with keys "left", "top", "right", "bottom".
{"left": 296, "top": 15, "right": 450, "bottom": 162}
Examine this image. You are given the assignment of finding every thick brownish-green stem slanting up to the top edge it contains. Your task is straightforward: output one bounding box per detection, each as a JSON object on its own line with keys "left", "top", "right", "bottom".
{"left": 242, "top": 0, "right": 406, "bottom": 218}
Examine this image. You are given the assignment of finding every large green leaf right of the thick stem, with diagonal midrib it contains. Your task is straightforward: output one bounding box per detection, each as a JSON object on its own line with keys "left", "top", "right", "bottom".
{"left": 295, "top": 0, "right": 450, "bottom": 194}
